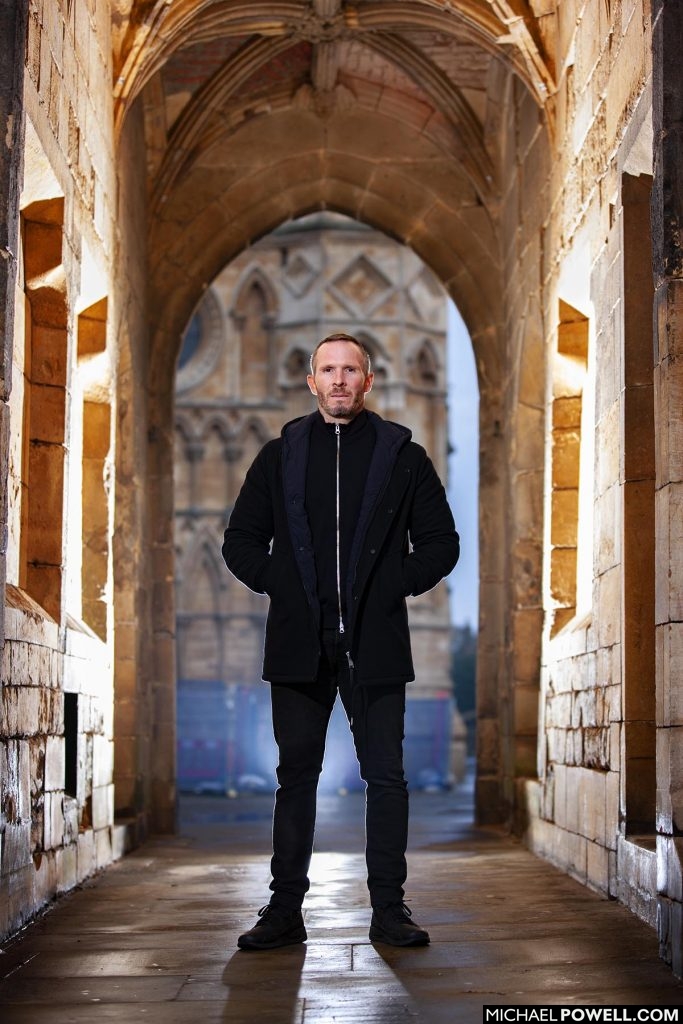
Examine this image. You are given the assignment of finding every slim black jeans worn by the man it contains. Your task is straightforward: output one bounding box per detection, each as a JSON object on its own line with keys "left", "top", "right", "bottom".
{"left": 270, "top": 632, "right": 408, "bottom": 909}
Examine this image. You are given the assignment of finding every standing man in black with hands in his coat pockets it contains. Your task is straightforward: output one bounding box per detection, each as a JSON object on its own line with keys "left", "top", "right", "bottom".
{"left": 222, "top": 334, "right": 460, "bottom": 949}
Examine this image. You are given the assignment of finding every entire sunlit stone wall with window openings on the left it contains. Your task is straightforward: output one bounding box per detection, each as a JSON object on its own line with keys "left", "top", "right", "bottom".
{"left": 0, "top": 0, "right": 150, "bottom": 935}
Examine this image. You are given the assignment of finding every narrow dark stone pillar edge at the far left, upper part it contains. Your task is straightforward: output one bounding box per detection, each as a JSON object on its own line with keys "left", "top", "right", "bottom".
{"left": 0, "top": 0, "right": 28, "bottom": 647}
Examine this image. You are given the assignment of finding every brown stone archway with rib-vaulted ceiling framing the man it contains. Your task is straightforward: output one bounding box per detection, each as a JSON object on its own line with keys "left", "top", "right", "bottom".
{"left": 108, "top": 0, "right": 553, "bottom": 828}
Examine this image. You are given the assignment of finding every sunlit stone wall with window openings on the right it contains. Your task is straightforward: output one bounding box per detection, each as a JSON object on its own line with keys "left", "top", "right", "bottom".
{"left": 499, "top": 3, "right": 656, "bottom": 924}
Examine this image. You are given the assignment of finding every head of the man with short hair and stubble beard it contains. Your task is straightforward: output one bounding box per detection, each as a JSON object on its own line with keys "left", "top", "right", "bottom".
{"left": 306, "top": 341, "right": 374, "bottom": 423}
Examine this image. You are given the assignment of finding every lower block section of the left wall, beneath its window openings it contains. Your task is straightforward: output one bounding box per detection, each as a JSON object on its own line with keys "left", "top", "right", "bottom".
{"left": 0, "top": 586, "right": 121, "bottom": 935}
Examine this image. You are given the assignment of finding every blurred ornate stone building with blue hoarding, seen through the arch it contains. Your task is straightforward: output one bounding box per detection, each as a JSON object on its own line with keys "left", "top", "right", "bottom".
{"left": 175, "top": 213, "right": 462, "bottom": 790}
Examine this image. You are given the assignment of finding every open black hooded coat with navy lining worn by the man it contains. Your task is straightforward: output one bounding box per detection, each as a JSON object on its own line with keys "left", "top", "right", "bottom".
{"left": 222, "top": 412, "right": 460, "bottom": 684}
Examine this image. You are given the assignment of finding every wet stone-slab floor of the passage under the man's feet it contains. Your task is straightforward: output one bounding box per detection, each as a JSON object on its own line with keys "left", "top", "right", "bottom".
{"left": 0, "top": 774, "right": 683, "bottom": 1024}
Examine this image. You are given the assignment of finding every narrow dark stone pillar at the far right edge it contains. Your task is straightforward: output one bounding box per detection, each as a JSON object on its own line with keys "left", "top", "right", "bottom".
{"left": 652, "top": 0, "right": 683, "bottom": 976}
